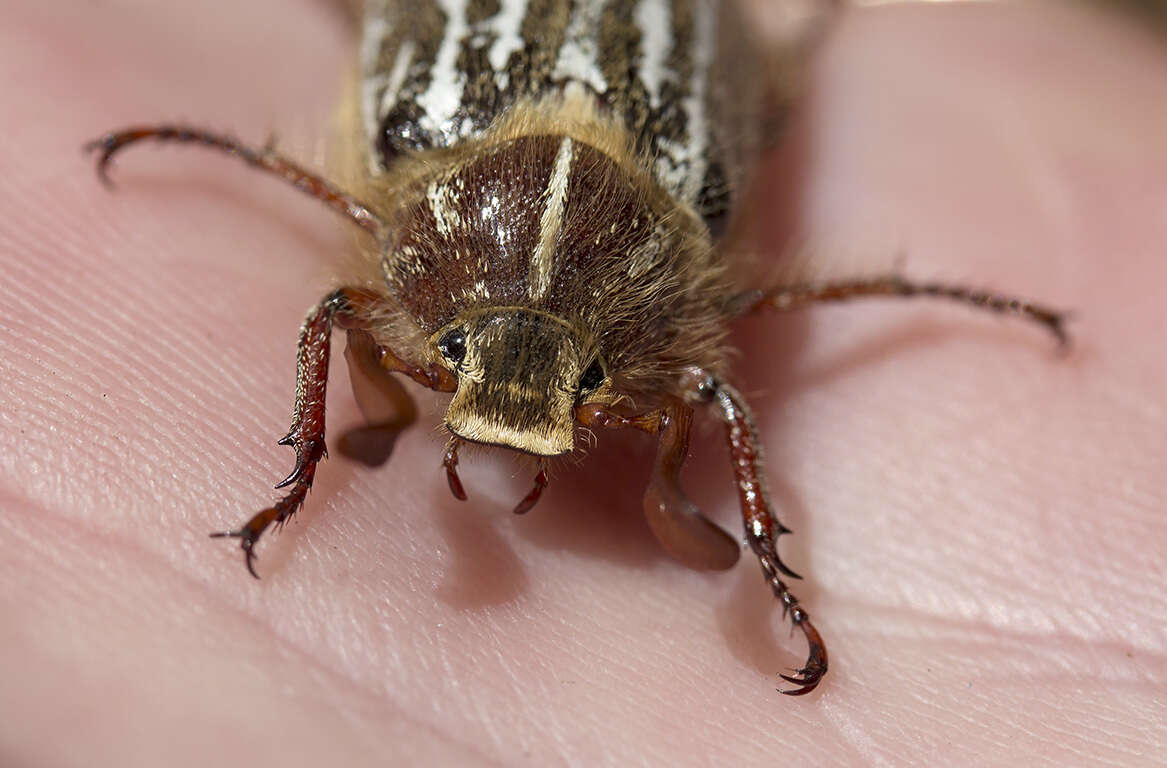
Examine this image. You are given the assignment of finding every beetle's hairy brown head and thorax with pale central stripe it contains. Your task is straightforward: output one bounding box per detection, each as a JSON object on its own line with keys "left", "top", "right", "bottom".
{"left": 371, "top": 107, "right": 727, "bottom": 455}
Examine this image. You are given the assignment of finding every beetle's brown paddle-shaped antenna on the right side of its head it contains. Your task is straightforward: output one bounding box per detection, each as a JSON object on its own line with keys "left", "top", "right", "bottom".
{"left": 575, "top": 400, "right": 741, "bottom": 571}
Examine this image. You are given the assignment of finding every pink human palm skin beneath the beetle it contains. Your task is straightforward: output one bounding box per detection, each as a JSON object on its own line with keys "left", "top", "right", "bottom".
{"left": 0, "top": 0, "right": 1167, "bottom": 767}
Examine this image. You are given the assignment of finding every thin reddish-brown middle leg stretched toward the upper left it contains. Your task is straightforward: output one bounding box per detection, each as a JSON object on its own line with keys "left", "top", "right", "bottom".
{"left": 85, "top": 125, "right": 386, "bottom": 242}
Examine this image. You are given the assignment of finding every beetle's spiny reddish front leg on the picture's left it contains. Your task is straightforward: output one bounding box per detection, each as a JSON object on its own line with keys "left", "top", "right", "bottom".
{"left": 211, "top": 288, "right": 368, "bottom": 579}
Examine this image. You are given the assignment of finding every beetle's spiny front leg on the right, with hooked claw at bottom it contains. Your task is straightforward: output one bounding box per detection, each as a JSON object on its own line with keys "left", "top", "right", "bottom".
{"left": 690, "top": 370, "right": 827, "bottom": 696}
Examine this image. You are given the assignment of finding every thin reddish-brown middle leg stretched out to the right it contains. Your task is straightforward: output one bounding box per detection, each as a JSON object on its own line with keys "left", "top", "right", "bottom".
{"left": 736, "top": 274, "right": 1069, "bottom": 345}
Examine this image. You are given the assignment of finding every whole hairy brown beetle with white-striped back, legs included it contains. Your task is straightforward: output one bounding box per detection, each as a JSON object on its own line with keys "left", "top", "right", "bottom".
{"left": 89, "top": 0, "right": 1064, "bottom": 693}
